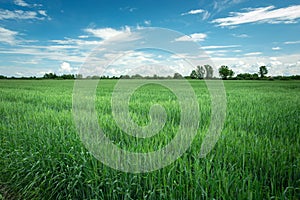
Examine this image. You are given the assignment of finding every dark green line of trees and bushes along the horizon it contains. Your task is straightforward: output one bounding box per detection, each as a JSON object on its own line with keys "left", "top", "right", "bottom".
{"left": 0, "top": 65, "right": 300, "bottom": 80}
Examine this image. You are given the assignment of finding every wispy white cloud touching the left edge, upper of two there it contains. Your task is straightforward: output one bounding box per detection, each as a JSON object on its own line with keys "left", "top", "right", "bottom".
{"left": 0, "top": 10, "right": 44, "bottom": 20}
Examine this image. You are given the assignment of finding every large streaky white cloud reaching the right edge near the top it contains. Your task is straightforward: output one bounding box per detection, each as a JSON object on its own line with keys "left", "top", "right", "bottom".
{"left": 212, "top": 5, "right": 300, "bottom": 27}
